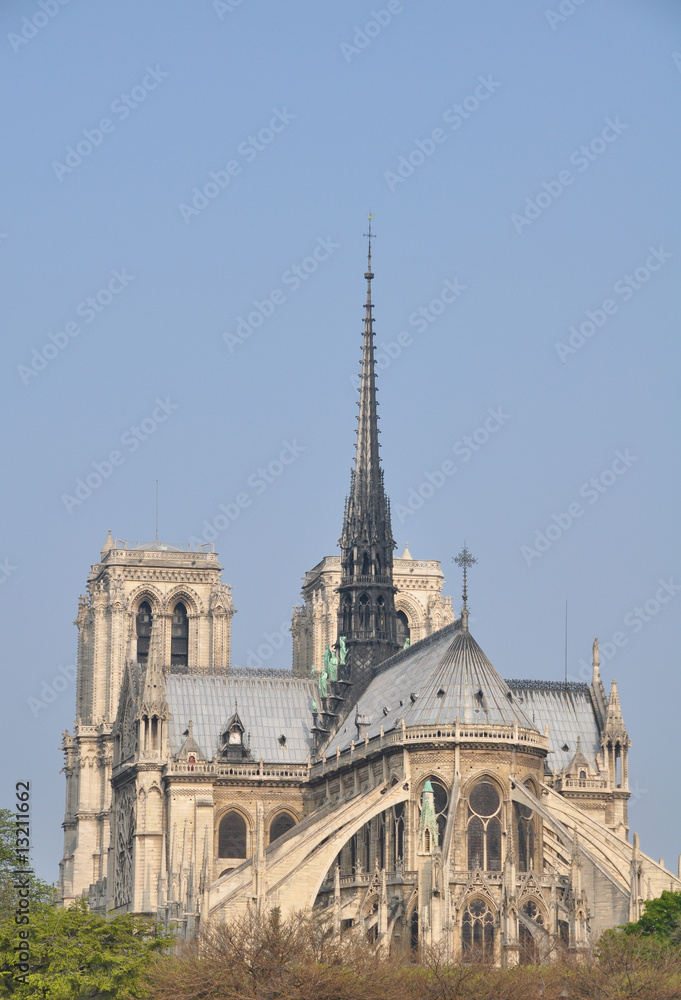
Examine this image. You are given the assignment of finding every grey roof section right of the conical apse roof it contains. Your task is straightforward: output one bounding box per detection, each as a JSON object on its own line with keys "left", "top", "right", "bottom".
{"left": 508, "top": 680, "right": 601, "bottom": 771}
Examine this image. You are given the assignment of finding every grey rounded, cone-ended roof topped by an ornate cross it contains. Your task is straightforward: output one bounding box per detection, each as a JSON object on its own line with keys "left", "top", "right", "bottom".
{"left": 327, "top": 622, "right": 543, "bottom": 755}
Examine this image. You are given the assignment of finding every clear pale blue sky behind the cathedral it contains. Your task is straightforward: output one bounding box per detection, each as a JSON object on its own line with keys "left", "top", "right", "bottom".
{"left": 0, "top": 0, "right": 681, "bottom": 879}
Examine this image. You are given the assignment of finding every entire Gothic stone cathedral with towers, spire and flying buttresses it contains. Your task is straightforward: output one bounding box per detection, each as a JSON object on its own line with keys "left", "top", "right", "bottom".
{"left": 59, "top": 235, "right": 681, "bottom": 966}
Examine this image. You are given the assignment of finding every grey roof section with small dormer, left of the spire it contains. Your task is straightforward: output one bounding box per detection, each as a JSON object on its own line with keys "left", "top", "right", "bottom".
{"left": 165, "top": 671, "right": 316, "bottom": 763}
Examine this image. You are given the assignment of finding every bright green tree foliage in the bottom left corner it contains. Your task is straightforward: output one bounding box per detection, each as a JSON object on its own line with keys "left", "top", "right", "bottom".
{"left": 0, "top": 900, "right": 172, "bottom": 1000}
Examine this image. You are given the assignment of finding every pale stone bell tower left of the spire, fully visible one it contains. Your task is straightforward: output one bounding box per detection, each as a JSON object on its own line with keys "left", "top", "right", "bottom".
{"left": 59, "top": 532, "right": 234, "bottom": 903}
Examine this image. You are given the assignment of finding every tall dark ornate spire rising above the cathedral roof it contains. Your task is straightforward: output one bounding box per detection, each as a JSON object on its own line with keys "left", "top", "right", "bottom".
{"left": 338, "top": 216, "right": 398, "bottom": 687}
